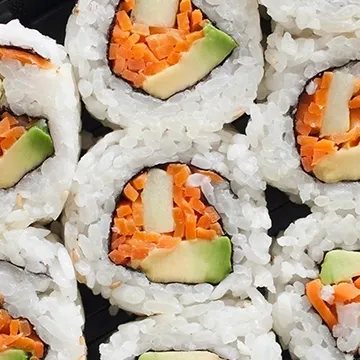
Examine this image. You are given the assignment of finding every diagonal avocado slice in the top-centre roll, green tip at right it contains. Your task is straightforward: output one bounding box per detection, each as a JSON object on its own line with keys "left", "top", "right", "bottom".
{"left": 143, "top": 24, "right": 237, "bottom": 100}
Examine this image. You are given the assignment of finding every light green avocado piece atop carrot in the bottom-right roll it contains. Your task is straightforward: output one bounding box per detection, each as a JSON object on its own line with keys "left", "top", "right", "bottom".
{"left": 320, "top": 250, "right": 360, "bottom": 285}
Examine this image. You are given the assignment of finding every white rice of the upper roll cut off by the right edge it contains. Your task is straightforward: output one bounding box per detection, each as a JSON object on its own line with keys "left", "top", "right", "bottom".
{"left": 246, "top": 26, "right": 360, "bottom": 214}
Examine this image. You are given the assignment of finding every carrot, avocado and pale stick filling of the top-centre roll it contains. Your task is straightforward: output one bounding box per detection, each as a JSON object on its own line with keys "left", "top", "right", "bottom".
{"left": 108, "top": 0, "right": 237, "bottom": 100}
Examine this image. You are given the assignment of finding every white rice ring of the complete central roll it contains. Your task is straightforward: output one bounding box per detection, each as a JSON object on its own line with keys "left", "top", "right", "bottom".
{"left": 63, "top": 131, "right": 273, "bottom": 315}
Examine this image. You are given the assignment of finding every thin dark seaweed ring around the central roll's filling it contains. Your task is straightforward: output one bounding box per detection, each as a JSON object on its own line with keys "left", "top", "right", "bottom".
{"left": 108, "top": 162, "right": 236, "bottom": 286}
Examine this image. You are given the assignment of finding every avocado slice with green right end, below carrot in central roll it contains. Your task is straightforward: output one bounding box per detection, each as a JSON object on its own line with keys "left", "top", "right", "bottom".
{"left": 140, "top": 236, "right": 232, "bottom": 284}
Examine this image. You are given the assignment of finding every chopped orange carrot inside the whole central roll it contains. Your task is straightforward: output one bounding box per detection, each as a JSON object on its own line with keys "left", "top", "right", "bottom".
{"left": 109, "top": 164, "right": 224, "bottom": 266}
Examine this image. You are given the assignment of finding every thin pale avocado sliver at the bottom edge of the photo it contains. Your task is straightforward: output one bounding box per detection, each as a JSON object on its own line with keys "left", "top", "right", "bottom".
{"left": 139, "top": 351, "right": 220, "bottom": 360}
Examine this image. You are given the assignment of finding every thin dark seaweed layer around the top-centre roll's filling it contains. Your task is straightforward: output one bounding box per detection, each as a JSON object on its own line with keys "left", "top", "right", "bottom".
{"left": 106, "top": 0, "right": 238, "bottom": 102}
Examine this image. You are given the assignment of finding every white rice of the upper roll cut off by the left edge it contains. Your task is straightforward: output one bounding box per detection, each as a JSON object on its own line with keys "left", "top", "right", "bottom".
{"left": 0, "top": 21, "right": 80, "bottom": 231}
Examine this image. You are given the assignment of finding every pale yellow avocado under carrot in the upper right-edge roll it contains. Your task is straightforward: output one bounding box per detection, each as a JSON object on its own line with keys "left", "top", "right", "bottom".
{"left": 313, "top": 146, "right": 360, "bottom": 184}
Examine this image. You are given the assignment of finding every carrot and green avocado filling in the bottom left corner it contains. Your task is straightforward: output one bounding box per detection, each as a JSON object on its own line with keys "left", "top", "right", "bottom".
{"left": 0, "top": 307, "right": 45, "bottom": 360}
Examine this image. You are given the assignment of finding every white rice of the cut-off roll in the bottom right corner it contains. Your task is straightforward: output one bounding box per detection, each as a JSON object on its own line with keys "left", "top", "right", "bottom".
{"left": 273, "top": 212, "right": 360, "bottom": 360}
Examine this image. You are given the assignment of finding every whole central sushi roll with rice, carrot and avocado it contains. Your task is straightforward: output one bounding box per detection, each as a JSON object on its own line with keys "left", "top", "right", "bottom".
{"left": 63, "top": 131, "right": 272, "bottom": 315}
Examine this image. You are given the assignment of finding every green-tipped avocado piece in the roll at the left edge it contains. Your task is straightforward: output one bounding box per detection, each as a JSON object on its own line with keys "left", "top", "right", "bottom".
{"left": 0, "top": 120, "right": 54, "bottom": 189}
